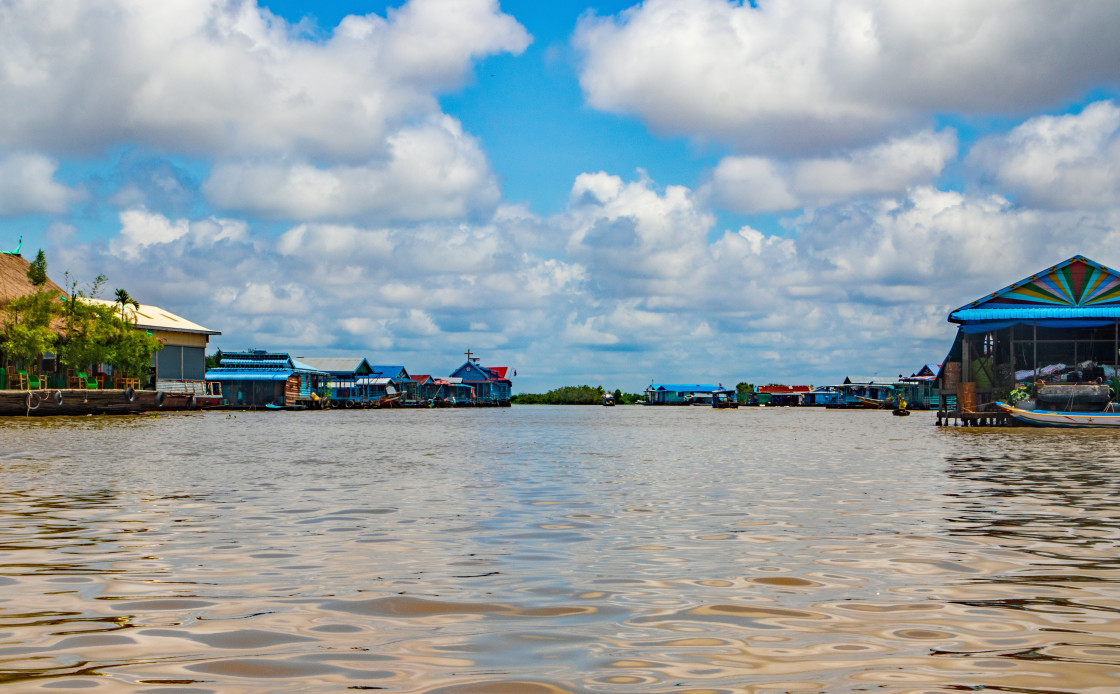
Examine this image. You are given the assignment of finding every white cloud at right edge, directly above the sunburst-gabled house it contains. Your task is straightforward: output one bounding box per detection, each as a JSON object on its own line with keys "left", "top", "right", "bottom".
{"left": 969, "top": 102, "right": 1120, "bottom": 209}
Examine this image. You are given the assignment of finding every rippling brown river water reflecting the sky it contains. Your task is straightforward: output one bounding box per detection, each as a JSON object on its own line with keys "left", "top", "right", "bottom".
{"left": 0, "top": 406, "right": 1120, "bottom": 694}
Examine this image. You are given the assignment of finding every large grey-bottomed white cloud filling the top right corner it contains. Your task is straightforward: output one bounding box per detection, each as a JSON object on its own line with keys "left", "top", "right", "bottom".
{"left": 575, "top": 0, "right": 1120, "bottom": 154}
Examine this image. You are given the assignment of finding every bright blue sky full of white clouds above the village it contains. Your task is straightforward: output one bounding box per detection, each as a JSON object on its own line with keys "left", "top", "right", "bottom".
{"left": 0, "top": 0, "right": 1120, "bottom": 392}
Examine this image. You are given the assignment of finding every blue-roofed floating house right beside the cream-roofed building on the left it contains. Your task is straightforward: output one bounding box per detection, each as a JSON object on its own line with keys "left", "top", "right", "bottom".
{"left": 206, "top": 349, "right": 330, "bottom": 409}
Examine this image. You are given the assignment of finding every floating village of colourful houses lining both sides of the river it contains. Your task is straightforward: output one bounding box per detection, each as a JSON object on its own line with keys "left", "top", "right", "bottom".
{"left": 0, "top": 246, "right": 1120, "bottom": 426}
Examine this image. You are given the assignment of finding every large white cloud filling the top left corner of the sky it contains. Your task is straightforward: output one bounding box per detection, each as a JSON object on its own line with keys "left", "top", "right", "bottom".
{"left": 0, "top": 0, "right": 529, "bottom": 158}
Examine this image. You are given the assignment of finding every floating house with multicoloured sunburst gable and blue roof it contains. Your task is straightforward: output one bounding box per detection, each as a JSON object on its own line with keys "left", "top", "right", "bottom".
{"left": 937, "top": 255, "right": 1120, "bottom": 424}
